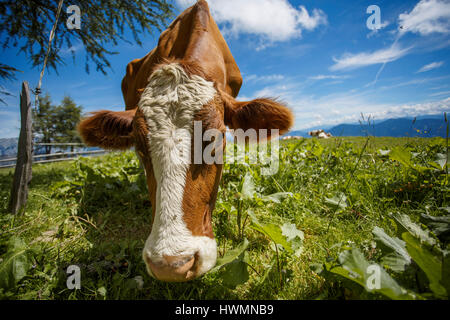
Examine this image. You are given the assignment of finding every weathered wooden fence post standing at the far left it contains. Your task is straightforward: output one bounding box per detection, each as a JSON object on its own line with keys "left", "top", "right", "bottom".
{"left": 9, "top": 81, "right": 33, "bottom": 214}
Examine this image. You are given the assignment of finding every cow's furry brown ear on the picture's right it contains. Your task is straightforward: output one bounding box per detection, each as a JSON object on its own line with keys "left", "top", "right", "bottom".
{"left": 220, "top": 91, "right": 294, "bottom": 137}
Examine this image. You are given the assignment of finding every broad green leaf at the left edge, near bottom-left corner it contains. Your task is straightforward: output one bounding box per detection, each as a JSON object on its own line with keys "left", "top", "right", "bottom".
{"left": 0, "top": 237, "right": 31, "bottom": 289}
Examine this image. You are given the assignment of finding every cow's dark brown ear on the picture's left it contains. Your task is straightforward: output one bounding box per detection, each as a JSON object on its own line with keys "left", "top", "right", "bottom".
{"left": 77, "top": 109, "right": 136, "bottom": 150}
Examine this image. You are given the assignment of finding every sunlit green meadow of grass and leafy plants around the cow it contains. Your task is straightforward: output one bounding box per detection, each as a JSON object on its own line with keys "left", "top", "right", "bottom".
{"left": 0, "top": 137, "right": 450, "bottom": 300}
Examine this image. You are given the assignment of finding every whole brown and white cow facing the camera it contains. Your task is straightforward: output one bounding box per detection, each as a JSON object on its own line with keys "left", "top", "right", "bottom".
{"left": 78, "top": 0, "right": 293, "bottom": 282}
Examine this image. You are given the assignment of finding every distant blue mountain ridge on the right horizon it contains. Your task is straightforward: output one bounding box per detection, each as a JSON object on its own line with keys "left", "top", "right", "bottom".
{"left": 328, "top": 116, "right": 447, "bottom": 138}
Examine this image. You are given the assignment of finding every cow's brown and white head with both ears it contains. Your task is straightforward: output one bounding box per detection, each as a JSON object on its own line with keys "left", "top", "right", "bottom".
{"left": 79, "top": 63, "right": 292, "bottom": 281}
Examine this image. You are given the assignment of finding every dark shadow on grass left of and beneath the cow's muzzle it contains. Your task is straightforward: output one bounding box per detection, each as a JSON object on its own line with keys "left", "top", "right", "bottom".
{"left": 47, "top": 172, "right": 238, "bottom": 300}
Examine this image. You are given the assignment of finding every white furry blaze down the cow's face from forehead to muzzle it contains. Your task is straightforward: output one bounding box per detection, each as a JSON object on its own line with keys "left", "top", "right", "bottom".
{"left": 139, "top": 63, "right": 217, "bottom": 275}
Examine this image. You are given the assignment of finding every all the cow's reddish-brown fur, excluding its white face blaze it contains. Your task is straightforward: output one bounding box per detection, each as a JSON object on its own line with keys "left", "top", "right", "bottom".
{"left": 78, "top": 0, "right": 293, "bottom": 276}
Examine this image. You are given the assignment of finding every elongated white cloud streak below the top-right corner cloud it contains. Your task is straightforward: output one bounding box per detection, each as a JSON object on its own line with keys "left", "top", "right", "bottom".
{"left": 330, "top": 44, "right": 411, "bottom": 71}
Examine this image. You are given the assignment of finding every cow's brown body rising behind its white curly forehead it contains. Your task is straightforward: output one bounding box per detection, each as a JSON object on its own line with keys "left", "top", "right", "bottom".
{"left": 122, "top": 0, "right": 242, "bottom": 110}
